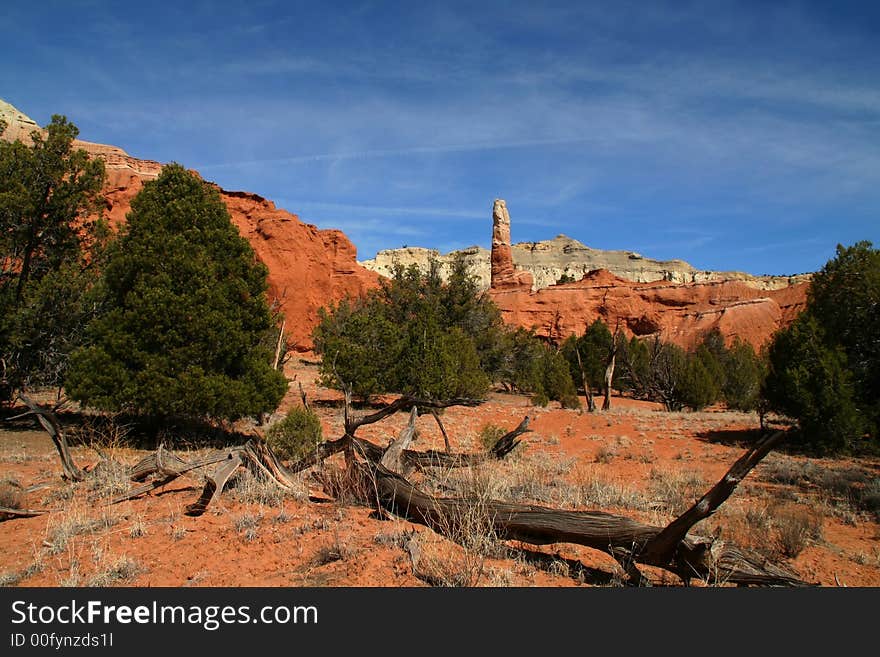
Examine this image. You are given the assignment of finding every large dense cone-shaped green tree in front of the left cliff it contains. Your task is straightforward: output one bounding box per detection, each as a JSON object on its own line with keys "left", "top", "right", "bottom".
{"left": 66, "top": 164, "right": 287, "bottom": 419}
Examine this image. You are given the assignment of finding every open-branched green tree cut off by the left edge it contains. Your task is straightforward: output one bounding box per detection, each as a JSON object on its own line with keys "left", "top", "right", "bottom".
{"left": 0, "top": 115, "right": 105, "bottom": 401}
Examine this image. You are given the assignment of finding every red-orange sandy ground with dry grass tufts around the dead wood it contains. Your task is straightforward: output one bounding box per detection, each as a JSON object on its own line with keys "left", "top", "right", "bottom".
{"left": 0, "top": 358, "right": 880, "bottom": 587}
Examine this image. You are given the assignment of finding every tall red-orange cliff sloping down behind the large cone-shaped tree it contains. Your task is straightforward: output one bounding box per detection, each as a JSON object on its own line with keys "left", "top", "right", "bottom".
{"left": 0, "top": 101, "right": 379, "bottom": 351}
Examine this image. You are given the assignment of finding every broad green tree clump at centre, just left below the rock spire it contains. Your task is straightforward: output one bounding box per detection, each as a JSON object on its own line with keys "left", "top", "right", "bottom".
{"left": 313, "top": 257, "right": 577, "bottom": 405}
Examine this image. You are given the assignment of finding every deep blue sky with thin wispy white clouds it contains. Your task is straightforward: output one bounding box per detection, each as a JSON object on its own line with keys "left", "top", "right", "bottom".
{"left": 0, "top": 0, "right": 880, "bottom": 274}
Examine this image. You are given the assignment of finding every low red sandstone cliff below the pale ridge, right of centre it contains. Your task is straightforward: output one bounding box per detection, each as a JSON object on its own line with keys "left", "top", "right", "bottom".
{"left": 489, "top": 217, "right": 808, "bottom": 348}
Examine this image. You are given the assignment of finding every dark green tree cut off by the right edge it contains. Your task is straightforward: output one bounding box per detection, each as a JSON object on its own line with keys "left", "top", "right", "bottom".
{"left": 765, "top": 241, "right": 880, "bottom": 451}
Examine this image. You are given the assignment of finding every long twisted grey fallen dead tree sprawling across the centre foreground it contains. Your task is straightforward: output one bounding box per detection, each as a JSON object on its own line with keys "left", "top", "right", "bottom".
{"left": 12, "top": 395, "right": 806, "bottom": 586}
